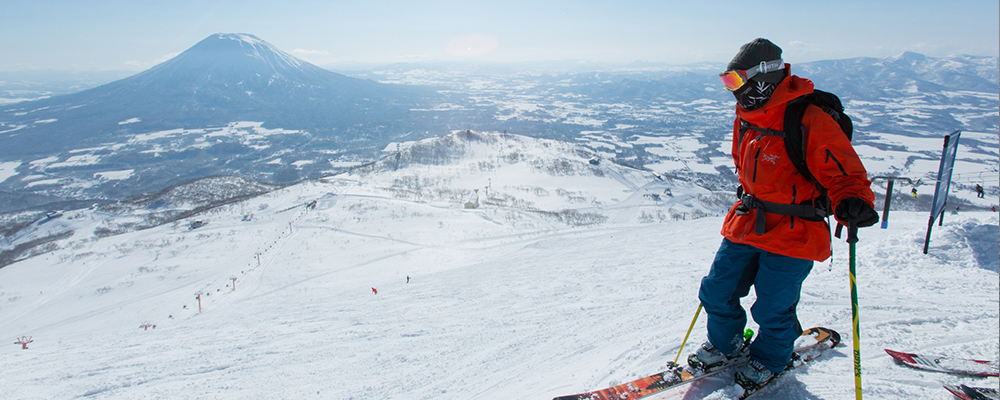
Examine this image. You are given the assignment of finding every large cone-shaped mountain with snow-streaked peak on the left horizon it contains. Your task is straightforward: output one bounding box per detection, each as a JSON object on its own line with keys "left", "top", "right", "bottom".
{"left": 0, "top": 34, "right": 428, "bottom": 151}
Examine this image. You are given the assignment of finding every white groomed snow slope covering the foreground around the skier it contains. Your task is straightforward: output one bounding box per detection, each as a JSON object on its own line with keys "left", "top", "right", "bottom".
{"left": 0, "top": 136, "right": 1000, "bottom": 400}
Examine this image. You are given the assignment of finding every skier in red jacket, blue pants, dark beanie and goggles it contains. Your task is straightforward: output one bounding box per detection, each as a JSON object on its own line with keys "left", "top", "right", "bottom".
{"left": 688, "top": 38, "right": 878, "bottom": 392}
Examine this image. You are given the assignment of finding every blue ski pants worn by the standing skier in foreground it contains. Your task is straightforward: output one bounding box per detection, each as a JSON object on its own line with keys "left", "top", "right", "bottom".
{"left": 698, "top": 239, "right": 813, "bottom": 372}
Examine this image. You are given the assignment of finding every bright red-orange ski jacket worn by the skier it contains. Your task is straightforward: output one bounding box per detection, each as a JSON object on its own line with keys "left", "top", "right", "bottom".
{"left": 722, "top": 70, "right": 875, "bottom": 261}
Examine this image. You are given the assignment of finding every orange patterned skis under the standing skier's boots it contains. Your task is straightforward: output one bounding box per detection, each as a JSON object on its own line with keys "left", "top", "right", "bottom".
{"left": 552, "top": 327, "right": 840, "bottom": 400}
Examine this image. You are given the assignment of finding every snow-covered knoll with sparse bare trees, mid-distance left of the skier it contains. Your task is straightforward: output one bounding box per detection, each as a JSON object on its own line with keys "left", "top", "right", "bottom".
{"left": 348, "top": 130, "right": 728, "bottom": 221}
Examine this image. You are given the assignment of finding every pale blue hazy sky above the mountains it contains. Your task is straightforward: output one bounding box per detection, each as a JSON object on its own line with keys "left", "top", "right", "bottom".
{"left": 0, "top": 0, "right": 1000, "bottom": 71}
